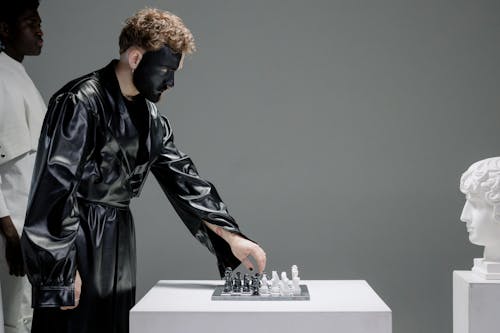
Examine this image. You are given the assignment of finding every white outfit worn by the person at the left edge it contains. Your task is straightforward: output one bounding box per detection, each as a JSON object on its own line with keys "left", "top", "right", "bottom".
{"left": 0, "top": 53, "right": 46, "bottom": 333}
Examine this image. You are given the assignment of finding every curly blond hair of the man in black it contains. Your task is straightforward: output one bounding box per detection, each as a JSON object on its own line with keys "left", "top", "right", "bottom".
{"left": 119, "top": 8, "right": 196, "bottom": 54}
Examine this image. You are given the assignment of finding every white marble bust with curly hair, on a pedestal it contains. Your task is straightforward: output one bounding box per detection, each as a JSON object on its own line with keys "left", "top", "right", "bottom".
{"left": 460, "top": 157, "right": 500, "bottom": 279}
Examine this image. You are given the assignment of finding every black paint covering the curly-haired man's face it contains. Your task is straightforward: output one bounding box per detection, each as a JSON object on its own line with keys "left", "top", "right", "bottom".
{"left": 132, "top": 45, "right": 182, "bottom": 103}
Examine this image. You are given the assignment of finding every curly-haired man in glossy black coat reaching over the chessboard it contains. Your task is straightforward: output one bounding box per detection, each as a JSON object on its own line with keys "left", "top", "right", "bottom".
{"left": 22, "top": 9, "right": 266, "bottom": 333}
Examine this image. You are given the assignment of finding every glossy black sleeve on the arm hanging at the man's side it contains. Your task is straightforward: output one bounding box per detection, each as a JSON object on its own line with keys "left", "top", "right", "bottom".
{"left": 21, "top": 93, "right": 95, "bottom": 307}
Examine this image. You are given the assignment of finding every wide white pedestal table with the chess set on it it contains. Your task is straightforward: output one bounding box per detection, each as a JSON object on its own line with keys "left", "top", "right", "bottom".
{"left": 130, "top": 280, "right": 392, "bottom": 333}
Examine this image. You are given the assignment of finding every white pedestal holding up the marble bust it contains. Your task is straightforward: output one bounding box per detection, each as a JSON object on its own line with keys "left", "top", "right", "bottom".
{"left": 453, "top": 271, "right": 500, "bottom": 333}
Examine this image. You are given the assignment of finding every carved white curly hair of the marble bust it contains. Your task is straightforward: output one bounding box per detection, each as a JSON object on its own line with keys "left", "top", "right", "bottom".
{"left": 460, "top": 157, "right": 500, "bottom": 221}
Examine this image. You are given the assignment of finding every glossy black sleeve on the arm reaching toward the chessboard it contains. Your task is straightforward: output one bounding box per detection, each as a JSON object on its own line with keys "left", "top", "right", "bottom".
{"left": 151, "top": 117, "right": 246, "bottom": 276}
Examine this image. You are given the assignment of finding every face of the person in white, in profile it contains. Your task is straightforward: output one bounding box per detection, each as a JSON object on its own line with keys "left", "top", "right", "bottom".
{"left": 2, "top": 9, "right": 43, "bottom": 61}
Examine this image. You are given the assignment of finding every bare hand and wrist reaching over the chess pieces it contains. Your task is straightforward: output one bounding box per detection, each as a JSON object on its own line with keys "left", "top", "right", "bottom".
{"left": 203, "top": 221, "right": 266, "bottom": 273}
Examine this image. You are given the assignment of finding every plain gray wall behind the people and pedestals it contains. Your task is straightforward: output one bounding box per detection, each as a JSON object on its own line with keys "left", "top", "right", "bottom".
{"left": 25, "top": 0, "right": 500, "bottom": 333}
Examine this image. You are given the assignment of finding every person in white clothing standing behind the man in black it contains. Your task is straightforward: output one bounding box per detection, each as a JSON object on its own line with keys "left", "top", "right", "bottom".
{"left": 0, "top": 0, "right": 46, "bottom": 333}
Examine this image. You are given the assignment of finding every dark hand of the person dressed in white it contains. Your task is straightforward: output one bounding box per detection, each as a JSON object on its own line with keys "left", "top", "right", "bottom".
{"left": 0, "top": 216, "right": 25, "bottom": 276}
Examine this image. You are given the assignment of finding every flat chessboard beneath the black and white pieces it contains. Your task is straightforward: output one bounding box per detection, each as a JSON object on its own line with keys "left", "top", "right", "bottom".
{"left": 212, "top": 284, "right": 310, "bottom": 301}
